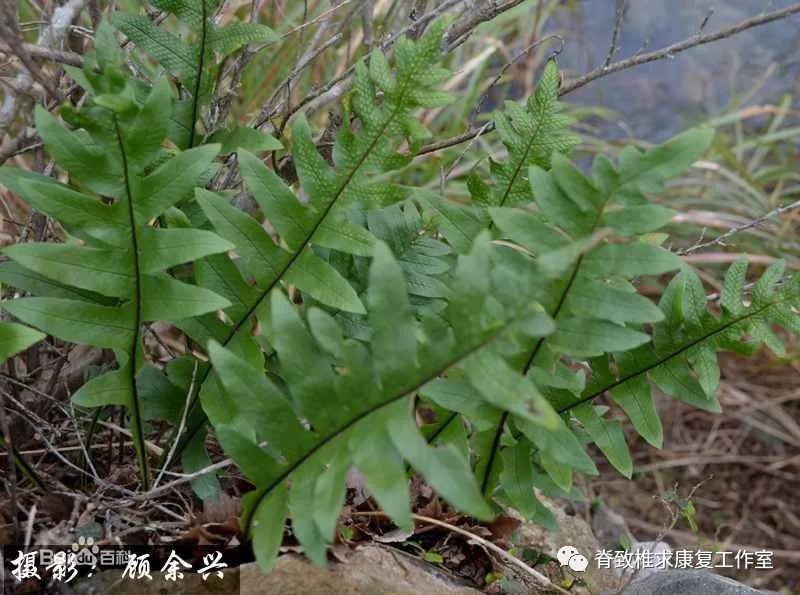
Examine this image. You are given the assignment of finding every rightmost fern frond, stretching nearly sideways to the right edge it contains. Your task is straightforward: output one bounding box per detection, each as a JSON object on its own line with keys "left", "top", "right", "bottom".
{"left": 558, "top": 259, "right": 800, "bottom": 428}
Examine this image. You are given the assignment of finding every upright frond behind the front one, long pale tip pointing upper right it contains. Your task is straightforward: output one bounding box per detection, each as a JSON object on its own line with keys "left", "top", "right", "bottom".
{"left": 468, "top": 130, "right": 711, "bottom": 506}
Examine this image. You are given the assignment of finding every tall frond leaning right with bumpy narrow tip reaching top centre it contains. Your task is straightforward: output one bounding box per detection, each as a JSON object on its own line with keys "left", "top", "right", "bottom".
{"left": 171, "top": 22, "right": 454, "bottom": 478}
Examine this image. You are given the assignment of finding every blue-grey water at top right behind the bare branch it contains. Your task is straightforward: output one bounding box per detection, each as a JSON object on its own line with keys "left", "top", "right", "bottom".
{"left": 549, "top": 0, "right": 800, "bottom": 142}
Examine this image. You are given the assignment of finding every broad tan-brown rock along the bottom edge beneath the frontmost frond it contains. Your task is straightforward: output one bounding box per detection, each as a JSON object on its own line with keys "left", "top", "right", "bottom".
{"left": 67, "top": 545, "right": 481, "bottom": 595}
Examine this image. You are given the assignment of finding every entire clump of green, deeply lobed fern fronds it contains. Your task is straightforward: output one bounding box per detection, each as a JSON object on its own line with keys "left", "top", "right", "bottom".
{"left": 0, "top": 0, "right": 800, "bottom": 569}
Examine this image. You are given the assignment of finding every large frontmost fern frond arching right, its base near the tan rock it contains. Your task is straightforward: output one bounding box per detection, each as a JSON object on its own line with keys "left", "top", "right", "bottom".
{"left": 208, "top": 236, "right": 559, "bottom": 567}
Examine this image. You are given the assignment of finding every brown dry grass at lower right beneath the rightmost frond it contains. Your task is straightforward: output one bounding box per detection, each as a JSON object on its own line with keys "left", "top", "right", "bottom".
{"left": 589, "top": 346, "right": 800, "bottom": 593}
